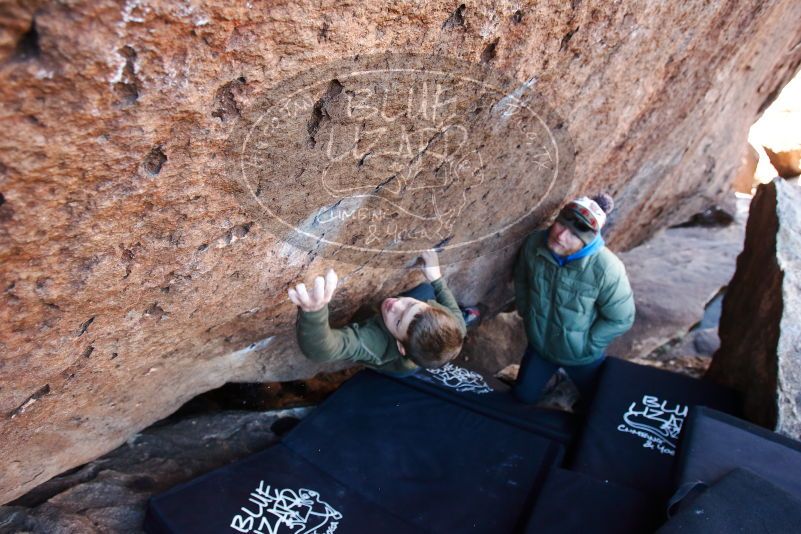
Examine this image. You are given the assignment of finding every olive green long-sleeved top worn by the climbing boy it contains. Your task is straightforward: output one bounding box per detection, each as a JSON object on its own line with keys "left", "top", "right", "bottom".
{"left": 296, "top": 278, "right": 467, "bottom": 374}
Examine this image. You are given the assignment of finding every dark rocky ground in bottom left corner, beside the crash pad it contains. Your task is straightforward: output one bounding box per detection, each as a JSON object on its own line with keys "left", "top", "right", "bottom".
{"left": 0, "top": 408, "right": 308, "bottom": 534}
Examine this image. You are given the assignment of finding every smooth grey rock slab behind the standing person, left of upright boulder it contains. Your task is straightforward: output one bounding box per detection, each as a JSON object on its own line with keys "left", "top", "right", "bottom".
{"left": 608, "top": 199, "right": 748, "bottom": 361}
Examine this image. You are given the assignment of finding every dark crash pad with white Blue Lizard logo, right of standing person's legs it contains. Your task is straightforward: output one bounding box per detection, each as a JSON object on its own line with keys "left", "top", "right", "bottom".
{"left": 570, "top": 357, "right": 739, "bottom": 498}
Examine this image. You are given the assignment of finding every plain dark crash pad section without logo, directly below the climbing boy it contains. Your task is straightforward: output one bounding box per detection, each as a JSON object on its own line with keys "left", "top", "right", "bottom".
{"left": 284, "top": 371, "right": 563, "bottom": 534}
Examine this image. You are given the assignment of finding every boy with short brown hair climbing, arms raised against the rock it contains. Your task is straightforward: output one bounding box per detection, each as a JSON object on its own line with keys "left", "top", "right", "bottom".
{"left": 289, "top": 251, "right": 466, "bottom": 376}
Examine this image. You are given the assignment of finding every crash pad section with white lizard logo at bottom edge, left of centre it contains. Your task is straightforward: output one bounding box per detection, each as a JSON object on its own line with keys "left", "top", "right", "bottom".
{"left": 144, "top": 444, "right": 422, "bottom": 534}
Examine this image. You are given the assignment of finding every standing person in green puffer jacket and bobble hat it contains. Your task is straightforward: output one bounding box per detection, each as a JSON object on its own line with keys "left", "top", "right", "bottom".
{"left": 513, "top": 194, "right": 634, "bottom": 403}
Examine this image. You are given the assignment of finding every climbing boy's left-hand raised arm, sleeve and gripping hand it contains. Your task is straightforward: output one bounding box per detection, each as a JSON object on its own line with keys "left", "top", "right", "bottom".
{"left": 288, "top": 269, "right": 362, "bottom": 362}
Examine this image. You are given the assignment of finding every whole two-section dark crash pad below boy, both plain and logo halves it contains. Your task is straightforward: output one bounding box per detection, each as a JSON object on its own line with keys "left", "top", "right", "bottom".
{"left": 146, "top": 371, "right": 563, "bottom": 534}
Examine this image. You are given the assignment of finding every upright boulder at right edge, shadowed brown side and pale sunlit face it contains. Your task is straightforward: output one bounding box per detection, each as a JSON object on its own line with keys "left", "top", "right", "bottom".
{"left": 708, "top": 178, "right": 801, "bottom": 439}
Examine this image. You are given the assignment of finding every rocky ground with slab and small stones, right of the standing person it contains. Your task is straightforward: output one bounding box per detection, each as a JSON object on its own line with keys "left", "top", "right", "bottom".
{"left": 609, "top": 196, "right": 750, "bottom": 377}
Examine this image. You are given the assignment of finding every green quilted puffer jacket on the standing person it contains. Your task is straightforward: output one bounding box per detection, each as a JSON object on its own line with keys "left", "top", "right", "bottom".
{"left": 515, "top": 230, "right": 634, "bottom": 365}
